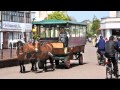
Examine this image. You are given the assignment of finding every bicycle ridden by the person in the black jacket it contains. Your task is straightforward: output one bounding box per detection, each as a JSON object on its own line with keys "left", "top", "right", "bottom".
{"left": 105, "top": 58, "right": 119, "bottom": 79}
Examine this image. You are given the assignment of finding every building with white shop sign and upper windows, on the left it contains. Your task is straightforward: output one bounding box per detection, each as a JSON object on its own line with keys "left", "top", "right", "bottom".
{"left": 0, "top": 11, "right": 32, "bottom": 48}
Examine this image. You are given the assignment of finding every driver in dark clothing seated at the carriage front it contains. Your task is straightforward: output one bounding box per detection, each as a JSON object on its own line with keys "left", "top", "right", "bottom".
{"left": 59, "top": 27, "right": 68, "bottom": 47}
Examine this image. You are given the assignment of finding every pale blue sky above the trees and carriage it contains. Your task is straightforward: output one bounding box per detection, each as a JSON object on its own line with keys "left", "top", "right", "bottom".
{"left": 67, "top": 11, "right": 109, "bottom": 22}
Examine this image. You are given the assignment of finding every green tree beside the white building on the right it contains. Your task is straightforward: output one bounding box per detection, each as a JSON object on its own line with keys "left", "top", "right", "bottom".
{"left": 91, "top": 17, "right": 100, "bottom": 34}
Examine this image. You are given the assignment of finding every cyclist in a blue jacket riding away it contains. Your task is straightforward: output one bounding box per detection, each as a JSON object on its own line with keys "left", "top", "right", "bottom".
{"left": 96, "top": 36, "right": 105, "bottom": 57}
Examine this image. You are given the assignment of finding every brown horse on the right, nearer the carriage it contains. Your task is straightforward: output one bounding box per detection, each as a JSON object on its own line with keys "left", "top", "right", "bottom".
{"left": 35, "top": 42, "right": 55, "bottom": 71}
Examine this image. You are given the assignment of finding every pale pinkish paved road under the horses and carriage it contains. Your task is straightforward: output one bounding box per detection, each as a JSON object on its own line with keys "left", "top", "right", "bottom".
{"left": 0, "top": 44, "right": 119, "bottom": 79}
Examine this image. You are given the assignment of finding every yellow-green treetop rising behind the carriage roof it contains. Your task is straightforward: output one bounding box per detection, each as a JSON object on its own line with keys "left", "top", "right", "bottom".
{"left": 45, "top": 11, "right": 70, "bottom": 21}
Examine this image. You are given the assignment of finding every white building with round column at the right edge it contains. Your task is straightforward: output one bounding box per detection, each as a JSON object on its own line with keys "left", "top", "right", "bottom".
{"left": 100, "top": 11, "right": 120, "bottom": 39}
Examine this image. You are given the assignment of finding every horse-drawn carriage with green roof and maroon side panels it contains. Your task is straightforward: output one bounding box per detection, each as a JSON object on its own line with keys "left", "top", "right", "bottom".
{"left": 32, "top": 20, "right": 87, "bottom": 68}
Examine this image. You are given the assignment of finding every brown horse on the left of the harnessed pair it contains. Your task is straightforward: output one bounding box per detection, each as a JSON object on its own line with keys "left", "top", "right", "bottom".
{"left": 16, "top": 41, "right": 37, "bottom": 73}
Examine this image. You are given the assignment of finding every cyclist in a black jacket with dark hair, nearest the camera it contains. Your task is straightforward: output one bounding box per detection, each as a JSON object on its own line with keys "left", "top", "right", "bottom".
{"left": 105, "top": 36, "right": 118, "bottom": 76}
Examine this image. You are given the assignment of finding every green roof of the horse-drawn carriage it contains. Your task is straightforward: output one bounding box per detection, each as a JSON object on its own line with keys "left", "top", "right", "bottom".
{"left": 32, "top": 20, "right": 86, "bottom": 25}
